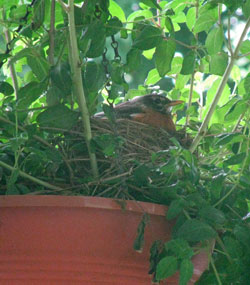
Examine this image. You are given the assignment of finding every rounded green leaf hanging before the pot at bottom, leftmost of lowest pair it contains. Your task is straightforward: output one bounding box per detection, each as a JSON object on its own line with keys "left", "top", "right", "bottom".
{"left": 156, "top": 256, "right": 178, "bottom": 280}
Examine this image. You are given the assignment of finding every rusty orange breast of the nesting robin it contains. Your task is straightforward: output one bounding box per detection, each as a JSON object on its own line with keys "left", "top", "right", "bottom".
{"left": 132, "top": 110, "right": 176, "bottom": 132}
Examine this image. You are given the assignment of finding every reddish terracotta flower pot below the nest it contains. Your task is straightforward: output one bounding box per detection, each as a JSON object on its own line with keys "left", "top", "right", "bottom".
{"left": 0, "top": 196, "right": 211, "bottom": 285}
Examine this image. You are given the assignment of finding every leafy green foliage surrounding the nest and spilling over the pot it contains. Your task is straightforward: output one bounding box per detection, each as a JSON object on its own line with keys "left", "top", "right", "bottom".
{"left": 0, "top": 0, "right": 250, "bottom": 284}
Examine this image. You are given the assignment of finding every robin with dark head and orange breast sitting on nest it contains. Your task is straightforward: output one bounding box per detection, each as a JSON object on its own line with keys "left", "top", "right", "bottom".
{"left": 94, "top": 94, "right": 183, "bottom": 132}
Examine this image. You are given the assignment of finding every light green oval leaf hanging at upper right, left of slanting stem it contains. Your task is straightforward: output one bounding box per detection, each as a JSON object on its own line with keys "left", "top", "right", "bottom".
{"left": 205, "top": 27, "right": 224, "bottom": 55}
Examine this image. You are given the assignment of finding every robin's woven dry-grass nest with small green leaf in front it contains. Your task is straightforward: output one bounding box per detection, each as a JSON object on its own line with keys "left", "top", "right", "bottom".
{"left": 66, "top": 118, "right": 191, "bottom": 182}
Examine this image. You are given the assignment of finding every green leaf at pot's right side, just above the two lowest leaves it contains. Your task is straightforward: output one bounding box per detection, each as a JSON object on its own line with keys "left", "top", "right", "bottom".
{"left": 164, "top": 238, "right": 194, "bottom": 259}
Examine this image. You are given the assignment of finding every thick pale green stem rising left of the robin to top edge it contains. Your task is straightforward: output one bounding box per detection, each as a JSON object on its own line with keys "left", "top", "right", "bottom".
{"left": 67, "top": 0, "right": 98, "bottom": 177}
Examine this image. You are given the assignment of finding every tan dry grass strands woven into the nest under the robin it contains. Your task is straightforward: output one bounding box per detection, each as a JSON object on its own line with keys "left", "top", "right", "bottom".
{"left": 68, "top": 118, "right": 190, "bottom": 180}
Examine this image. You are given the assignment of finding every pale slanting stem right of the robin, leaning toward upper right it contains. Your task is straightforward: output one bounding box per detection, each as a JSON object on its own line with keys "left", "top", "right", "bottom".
{"left": 190, "top": 18, "right": 250, "bottom": 152}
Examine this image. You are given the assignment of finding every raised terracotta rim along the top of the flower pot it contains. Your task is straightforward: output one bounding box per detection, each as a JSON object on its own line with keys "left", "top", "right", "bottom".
{"left": 0, "top": 195, "right": 167, "bottom": 216}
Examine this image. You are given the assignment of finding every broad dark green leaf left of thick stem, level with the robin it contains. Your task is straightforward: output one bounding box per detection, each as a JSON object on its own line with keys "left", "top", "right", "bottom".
{"left": 37, "top": 104, "right": 79, "bottom": 129}
